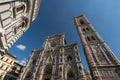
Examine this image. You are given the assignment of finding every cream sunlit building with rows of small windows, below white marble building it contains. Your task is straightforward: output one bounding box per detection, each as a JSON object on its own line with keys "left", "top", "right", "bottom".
{"left": 0, "top": 53, "right": 16, "bottom": 80}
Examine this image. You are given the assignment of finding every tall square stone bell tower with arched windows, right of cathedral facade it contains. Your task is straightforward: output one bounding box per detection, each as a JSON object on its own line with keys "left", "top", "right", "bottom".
{"left": 74, "top": 15, "right": 120, "bottom": 80}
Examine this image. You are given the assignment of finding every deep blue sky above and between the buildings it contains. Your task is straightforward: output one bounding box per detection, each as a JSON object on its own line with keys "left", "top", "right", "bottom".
{"left": 9, "top": 0, "right": 120, "bottom": 68}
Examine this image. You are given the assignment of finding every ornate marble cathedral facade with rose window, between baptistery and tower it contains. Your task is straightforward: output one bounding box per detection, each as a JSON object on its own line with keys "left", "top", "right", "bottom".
{"left": 19, "top": 34, "right": 90, "bottom": 80}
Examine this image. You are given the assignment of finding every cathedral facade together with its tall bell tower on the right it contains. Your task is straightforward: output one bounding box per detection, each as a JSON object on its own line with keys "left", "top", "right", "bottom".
{"left": 19, "top": 15, "right": 120, "bottom": 80}
